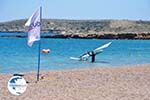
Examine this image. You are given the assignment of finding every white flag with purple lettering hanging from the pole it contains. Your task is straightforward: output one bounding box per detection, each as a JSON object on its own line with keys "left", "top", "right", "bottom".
{"left": 25, "top": 9, "right": 41, "bottom": 47}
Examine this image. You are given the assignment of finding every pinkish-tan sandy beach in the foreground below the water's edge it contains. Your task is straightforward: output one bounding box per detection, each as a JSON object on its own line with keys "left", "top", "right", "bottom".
{"left": 0, "top": 65, "right": 150, "bottom": 100}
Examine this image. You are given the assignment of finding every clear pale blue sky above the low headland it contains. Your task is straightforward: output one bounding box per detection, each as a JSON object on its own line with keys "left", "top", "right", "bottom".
{"left": 0, "top": 0, "right": 150, "bottom": 22}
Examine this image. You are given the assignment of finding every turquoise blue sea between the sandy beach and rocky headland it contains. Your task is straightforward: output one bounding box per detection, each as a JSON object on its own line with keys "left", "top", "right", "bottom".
{"left": 0, "top": 33, "right": 150, "bottom": 73}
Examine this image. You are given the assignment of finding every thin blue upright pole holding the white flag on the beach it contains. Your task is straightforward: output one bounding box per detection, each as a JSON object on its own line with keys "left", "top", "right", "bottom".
{"left": 37, "top": 6, "right": 42, "bottom": 81}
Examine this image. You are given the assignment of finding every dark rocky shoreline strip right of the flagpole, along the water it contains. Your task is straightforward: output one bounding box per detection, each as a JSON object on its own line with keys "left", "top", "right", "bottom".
{"left": 42, "top": 33, "right": 150, "bottom": 40}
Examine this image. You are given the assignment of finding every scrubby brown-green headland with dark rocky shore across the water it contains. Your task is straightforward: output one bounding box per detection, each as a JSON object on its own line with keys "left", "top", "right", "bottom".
{"left": 0, "top": 19, "right": 150, "bottom": 39}
